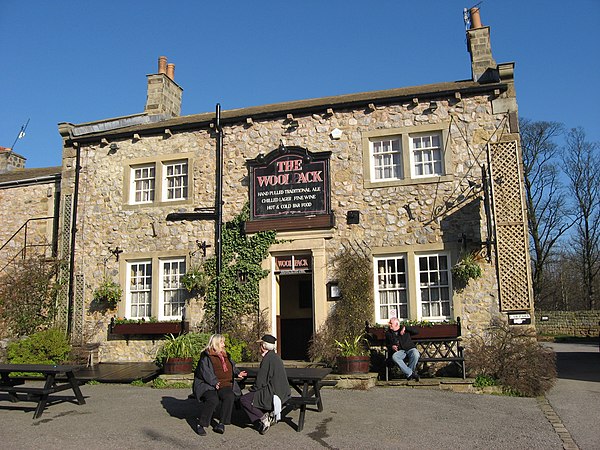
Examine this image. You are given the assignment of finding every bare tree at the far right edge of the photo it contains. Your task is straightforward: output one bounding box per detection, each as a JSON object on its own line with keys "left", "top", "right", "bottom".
{"left": 564, "top": 127, "right": 600, "bottom": 309}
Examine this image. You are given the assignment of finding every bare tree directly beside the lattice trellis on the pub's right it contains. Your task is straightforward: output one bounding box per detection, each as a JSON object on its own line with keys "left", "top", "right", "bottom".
{"left": 519, "top": 119, "right": 574, "bottom": 304}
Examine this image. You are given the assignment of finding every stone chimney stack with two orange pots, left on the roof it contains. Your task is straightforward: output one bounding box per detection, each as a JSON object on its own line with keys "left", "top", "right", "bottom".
{"left": 144, "top": 56, "right": 183, "bottom": 117}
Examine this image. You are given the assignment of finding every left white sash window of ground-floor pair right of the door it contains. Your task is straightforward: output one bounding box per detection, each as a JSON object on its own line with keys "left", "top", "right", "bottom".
{"left": 373, "top": 254, "right": 410, "bottom": 322}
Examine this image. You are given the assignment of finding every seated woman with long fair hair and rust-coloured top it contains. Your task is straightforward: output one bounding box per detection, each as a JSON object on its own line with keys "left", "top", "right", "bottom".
{"left": 192, "top": 334, "right": 247, "bottom": 436}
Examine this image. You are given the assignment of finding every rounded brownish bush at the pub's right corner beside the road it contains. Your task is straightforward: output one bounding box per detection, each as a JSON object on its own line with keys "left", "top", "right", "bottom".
{"left": 465, "top": 320, "right": 556, "bottom": 397}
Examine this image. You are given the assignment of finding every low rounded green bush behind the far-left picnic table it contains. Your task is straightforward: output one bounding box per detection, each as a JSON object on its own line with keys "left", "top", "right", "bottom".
{"left": 7, "top": 329, "right": 71, "bottom": 364}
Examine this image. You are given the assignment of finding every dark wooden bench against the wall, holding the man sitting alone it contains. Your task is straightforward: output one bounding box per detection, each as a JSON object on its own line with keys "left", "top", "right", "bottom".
{"left": 365, "top": 318, "right": 466, "bottom": 381}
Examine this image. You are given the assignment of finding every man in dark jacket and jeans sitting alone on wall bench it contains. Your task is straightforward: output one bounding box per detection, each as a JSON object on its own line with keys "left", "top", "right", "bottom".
{"left": 385, "top": 317, "right": 421, "bottom": 381}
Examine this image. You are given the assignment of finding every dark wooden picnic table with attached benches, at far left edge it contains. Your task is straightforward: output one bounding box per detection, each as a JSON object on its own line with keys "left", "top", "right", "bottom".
{"left": 0, "top": 364, "right": 85, "bottom": 419}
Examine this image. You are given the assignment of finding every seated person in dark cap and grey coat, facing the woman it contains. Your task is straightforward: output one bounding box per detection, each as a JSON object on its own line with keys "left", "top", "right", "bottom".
{"left": 240, "top": 334, "right": 292, "bottom": 434}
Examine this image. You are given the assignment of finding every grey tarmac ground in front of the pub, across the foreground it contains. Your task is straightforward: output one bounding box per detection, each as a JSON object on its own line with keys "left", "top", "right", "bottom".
{"left": 0, "top": 343, "right": 600, "bottom": 450}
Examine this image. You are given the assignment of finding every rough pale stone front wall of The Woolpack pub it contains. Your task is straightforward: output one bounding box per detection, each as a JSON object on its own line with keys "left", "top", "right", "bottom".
{"left": 63, "top": 95, "right": 507, "bottom": 360}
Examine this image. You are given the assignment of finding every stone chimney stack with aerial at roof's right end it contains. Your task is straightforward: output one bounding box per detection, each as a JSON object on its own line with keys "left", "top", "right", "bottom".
{"left": 467, "top": 7, "right": 499, "bottom": 83}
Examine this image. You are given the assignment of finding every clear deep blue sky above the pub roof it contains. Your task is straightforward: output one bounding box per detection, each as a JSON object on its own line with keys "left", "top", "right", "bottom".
{"left": 0, "top": 0, "right": 600, "bottom": 167}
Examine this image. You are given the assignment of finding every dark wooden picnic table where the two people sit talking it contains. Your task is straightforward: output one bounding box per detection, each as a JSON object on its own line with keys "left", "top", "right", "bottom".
{"left": 238, "top": 366, "right": 331, "bottom": 431}
